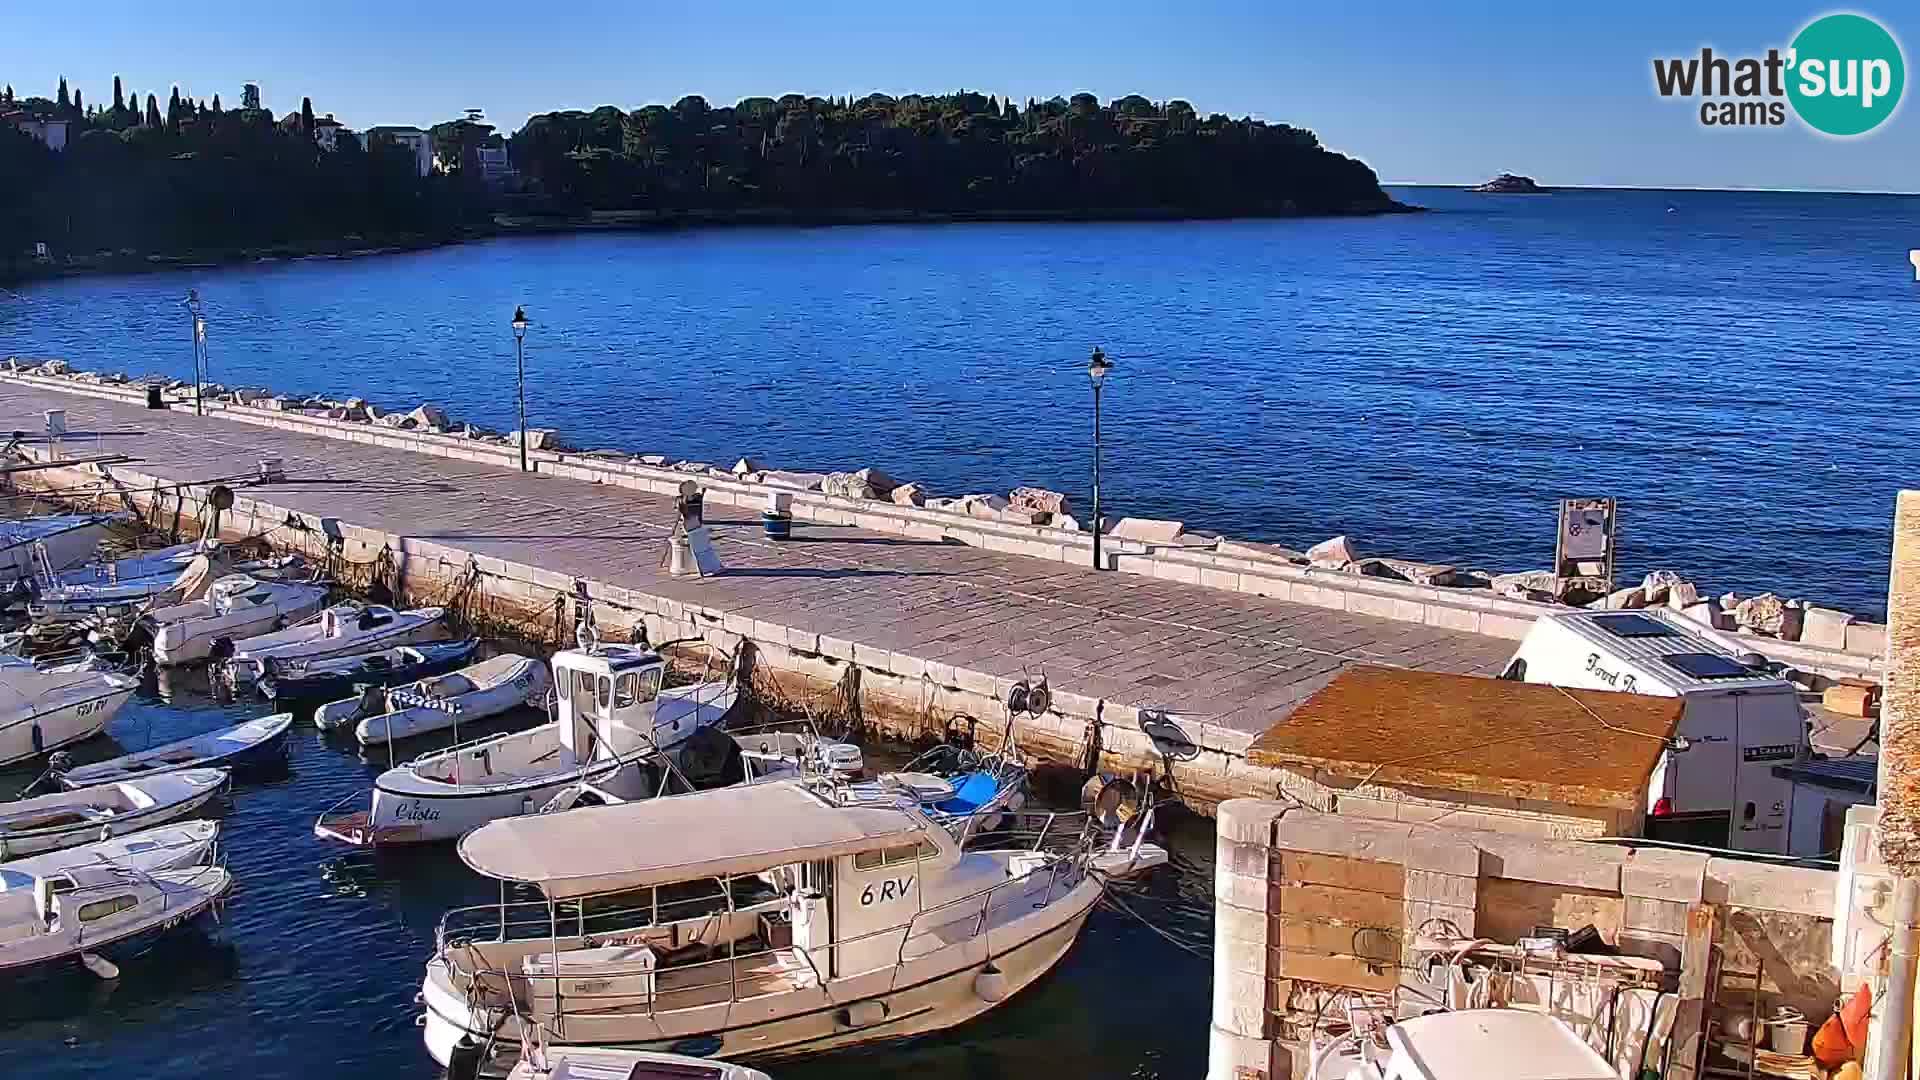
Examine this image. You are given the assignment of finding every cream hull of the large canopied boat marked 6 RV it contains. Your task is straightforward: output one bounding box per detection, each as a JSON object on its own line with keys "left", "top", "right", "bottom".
{"left": 420, "top": 880, "right": 1100, "bottom": 1070}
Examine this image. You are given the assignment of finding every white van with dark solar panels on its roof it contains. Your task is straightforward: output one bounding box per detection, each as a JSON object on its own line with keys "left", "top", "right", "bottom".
{"left": 1500, "top": 609, "right": 1807, "bottom": 855}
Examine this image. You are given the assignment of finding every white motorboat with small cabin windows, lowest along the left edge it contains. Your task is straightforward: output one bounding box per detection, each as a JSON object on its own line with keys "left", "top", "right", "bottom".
{"left": 0, "top": 865, "right": 232, "bottom": 978}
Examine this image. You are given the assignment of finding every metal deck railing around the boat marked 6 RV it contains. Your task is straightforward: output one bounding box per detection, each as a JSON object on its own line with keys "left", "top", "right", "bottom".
{"left": 440, "top": 845, "right": 1087, "bottom": 1024}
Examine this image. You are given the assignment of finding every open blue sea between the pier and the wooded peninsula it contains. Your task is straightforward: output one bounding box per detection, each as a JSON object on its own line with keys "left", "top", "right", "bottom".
{"left": 0, "top": 188, "right": 1920, "bottom": 613}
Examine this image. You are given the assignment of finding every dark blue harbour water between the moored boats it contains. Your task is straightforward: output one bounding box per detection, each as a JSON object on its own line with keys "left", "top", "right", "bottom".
{"left": 0, "top": 671, "right": 1213, "bottom": 1080}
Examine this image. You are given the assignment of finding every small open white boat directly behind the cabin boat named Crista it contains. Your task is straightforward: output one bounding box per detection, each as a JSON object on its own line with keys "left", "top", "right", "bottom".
{"left": 313, "top": 653, "right": 547, "bottom": 746}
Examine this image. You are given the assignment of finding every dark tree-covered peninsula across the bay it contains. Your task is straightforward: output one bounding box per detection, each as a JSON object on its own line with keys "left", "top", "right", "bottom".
{"left": 0, "top": 79, "right": 1400, "bottom": 275}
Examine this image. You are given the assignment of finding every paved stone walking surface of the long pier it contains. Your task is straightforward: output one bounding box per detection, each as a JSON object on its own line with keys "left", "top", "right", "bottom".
{"left": 0, "top": 380, "right": 1515, "bottom": 801}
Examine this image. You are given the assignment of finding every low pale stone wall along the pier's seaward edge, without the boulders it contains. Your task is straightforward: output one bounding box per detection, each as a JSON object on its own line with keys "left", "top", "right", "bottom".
{"left": 0, "top": 361, "right": 1885, "bottom": 678}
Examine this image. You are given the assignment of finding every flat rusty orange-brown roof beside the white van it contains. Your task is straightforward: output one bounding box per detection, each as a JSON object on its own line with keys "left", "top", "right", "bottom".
{"left": 1246, "top": 665, "right": 1686, "bottom": 809}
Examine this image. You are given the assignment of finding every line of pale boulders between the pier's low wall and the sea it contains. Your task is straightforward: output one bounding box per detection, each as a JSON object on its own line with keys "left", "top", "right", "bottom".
{"left": 0, "top": 357, "right": 1887, "bottom": 655}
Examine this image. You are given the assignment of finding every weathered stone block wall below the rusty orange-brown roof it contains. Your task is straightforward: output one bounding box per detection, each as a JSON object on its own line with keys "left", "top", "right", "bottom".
{"left": 1208, "top": 799, "right": 1851, "bottom": 1080}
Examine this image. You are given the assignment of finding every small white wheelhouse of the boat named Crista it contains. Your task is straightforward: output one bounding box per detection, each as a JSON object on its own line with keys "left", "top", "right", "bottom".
{"left": 553, "top": 644, "right": 674, "bottom": 763}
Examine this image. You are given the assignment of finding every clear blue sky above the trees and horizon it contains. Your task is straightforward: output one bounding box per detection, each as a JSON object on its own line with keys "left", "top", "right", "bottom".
{"left": 0, "top": 0, "right": 1920, "bottom": 190}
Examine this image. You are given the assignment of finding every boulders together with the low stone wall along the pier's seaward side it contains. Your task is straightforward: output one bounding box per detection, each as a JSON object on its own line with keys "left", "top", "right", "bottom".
{"left": 0, "top": 357, "right": 1885, "bottom": 675}
